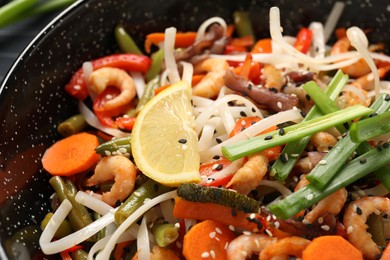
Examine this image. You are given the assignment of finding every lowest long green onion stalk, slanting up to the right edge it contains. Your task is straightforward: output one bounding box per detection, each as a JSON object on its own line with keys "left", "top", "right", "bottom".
{"left": 270, "top": 146, "right": 390, "bottom": 219}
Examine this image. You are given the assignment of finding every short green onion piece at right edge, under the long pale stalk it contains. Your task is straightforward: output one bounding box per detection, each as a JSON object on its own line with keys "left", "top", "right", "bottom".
{"left": 349, "top": 111, "right": 390, "bottom": 142}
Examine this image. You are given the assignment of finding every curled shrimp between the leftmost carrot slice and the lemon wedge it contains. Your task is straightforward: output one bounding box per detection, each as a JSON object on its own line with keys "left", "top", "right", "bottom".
{"left": 86, "top": 155, "right": 136, "bottom": 206}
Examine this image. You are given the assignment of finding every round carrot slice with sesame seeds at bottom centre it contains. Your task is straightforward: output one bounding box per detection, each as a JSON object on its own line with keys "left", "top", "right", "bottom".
{"left": 183, "top": 220, "right": 235, "bottom": 260}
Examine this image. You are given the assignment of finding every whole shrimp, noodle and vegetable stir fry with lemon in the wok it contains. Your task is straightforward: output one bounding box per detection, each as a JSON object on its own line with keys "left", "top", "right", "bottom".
{"left": 39, "top": 4, "right": 390, "bottom": 260}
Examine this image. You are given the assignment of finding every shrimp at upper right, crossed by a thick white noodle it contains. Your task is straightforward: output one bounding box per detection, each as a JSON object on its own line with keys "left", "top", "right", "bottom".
{"left": 331, "top": 36, "right": 371, "bottom": 78}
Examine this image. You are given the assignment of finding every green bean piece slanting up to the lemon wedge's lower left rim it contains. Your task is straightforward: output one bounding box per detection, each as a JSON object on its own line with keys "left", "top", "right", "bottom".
{"left": 115, "top": 179, "right": 170, "bottom": 225}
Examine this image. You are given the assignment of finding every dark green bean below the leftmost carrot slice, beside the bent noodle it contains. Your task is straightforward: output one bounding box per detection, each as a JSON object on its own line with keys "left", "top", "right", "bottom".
{"left": 49, "top": 176, "right": 92, "bottom": 230}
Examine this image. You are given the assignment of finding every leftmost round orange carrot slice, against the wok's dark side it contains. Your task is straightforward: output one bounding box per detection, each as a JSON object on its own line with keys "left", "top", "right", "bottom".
{"left": 42, "top": 132, "right": 100, "bottom": 176}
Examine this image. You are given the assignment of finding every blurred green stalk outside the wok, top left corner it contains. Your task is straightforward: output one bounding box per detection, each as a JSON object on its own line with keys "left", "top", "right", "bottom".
{"left": 0, "top": 0, "right": 38, "bottom": 27}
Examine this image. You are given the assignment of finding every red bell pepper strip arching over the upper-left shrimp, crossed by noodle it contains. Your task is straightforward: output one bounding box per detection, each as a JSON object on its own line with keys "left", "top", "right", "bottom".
{"left": 65, "top": 53, "right": 152, "bottom": 100}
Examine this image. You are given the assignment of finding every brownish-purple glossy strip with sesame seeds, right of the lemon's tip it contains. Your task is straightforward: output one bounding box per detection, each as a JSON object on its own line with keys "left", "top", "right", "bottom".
{"left": 224, "top": 70, "right": 299, "bottom": 112}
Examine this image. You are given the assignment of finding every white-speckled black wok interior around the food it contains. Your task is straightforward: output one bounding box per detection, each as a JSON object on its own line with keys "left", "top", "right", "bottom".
{"left": 0, "top": 0, "right": 390, "bottom": 259}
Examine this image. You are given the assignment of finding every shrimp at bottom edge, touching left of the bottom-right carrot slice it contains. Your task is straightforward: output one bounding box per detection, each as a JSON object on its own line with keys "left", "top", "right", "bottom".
{"left": 259, "top": 236, "right": 310, "bottom": 260}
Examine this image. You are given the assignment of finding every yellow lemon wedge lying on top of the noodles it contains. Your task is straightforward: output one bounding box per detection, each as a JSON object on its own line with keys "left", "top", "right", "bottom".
{"left": 131, "top": 82, "right": 200, "bottom": 186}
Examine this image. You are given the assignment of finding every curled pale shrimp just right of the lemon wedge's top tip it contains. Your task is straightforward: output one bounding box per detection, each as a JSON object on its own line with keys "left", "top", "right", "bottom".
{"left": 192, "top": 58, "right": 229, "bottom": 98}
